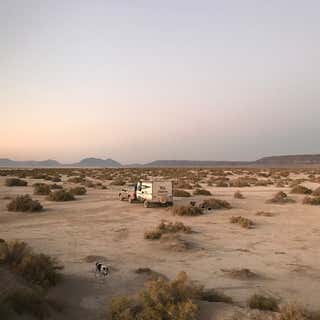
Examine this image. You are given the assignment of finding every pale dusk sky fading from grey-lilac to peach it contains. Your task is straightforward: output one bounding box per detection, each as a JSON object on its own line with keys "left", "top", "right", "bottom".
{"left": 0, "top": 0, "right": 320, "bottom": 163}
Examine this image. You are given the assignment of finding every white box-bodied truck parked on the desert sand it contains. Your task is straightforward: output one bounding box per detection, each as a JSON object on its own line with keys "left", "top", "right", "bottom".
{"left": 119, "top": 180, "right": 173, "bottom": 208}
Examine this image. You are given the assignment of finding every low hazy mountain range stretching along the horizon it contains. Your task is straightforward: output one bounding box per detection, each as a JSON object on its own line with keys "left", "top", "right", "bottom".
{"left": 0, "top": 154, "right": 320, "bottom": 168}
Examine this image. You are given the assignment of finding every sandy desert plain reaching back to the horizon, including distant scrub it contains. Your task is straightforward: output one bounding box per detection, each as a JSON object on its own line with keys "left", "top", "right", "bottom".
{"left": 0, "top": 168, "right": 320, "bottom": 320}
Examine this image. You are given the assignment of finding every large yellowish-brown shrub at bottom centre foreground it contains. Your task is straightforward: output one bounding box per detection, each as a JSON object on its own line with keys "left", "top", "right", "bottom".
{"left": 109, "top": 272, "right": 232, "bottom": 320}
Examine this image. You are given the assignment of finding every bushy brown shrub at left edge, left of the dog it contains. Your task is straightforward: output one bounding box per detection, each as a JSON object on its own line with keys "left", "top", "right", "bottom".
{"left": 0, "top": 241, "right": 62, "bottom": 288}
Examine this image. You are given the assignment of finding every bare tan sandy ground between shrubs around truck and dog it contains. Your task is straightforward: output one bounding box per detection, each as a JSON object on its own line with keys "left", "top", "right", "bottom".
{"left": 0, "top": 177, "right": 320, "bottom": 320}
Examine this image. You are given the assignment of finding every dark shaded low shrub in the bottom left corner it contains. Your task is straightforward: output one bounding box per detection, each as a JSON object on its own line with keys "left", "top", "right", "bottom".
{"left": 4, "top": 288, "right": 51, "bottom": 320}
